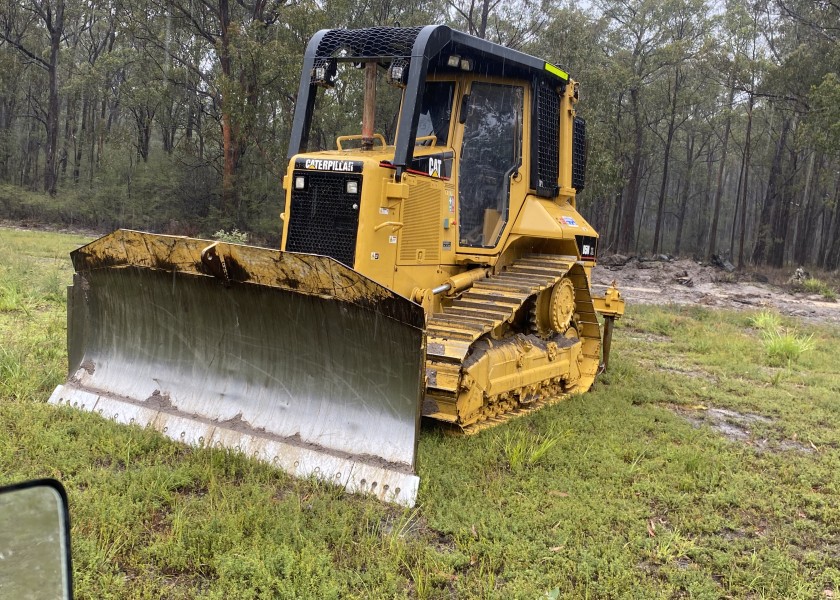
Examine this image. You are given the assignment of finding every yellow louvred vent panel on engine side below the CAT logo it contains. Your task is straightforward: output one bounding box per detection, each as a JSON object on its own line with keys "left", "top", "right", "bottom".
{"left": 400, "top": 180, "right": 441, "bottom": 263}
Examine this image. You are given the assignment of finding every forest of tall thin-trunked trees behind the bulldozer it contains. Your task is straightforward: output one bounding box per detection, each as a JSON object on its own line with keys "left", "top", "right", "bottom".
{"left": 0, "top": 0, "right": 840, "bottom": 270}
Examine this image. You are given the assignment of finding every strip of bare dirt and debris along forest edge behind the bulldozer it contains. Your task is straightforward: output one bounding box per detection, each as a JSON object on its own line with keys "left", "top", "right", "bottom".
{"left": 592, "top": 256, "right": 840, "bottom": 324}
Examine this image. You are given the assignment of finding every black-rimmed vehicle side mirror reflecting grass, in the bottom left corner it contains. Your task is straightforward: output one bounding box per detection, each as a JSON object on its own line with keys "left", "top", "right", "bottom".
{"left": 0, "top": 479, "right": 73, "bottom": 600}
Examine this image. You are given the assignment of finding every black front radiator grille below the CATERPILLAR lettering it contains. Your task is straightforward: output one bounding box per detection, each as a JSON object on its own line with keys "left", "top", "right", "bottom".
{"left": 286, "top": 171, "right": 362, "bottom": 268}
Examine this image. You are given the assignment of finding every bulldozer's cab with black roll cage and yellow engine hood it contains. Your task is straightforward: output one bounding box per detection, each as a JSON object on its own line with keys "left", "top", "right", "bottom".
{"left": 283, "top": 26, "right": 583, "bottom": 278}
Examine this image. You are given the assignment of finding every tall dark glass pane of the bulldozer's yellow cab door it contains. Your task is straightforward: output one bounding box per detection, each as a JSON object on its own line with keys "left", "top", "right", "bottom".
{"left": 458, "top": 81, "right": 527, "bottom": 252}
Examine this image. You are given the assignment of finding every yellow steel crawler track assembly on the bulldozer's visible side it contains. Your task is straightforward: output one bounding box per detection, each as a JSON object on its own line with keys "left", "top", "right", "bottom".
{"left": 423, "top": 255, "right": 601, "bottom": 433}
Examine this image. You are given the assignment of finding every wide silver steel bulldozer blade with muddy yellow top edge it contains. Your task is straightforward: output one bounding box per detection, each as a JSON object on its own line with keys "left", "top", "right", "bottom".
{"left": 50, "top": 230, "right": 426, "bottom": 506}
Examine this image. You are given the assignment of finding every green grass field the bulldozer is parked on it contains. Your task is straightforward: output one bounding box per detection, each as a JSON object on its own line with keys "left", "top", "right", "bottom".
{"left": 0, "top": 229, "right": 840, "bottom": 599}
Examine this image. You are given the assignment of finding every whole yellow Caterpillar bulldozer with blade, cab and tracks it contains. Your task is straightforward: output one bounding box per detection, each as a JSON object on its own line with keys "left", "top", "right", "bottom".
{"left": 50, "top": 26, "right": 624, "bottom": 505}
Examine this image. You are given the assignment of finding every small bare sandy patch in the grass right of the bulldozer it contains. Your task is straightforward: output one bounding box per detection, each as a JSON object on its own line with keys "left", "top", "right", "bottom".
{"left": 670, "top": 406, "right": 816, "bottom": 454}
